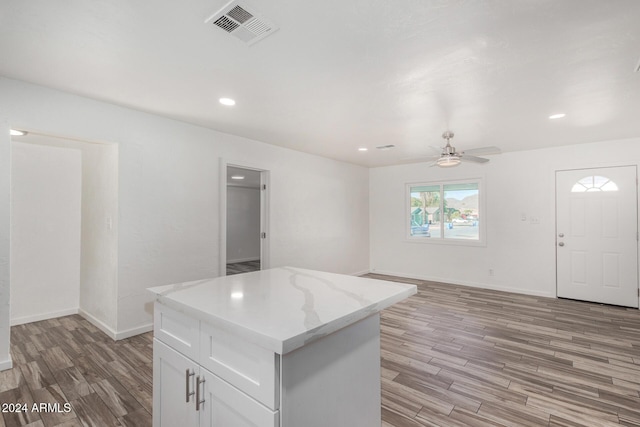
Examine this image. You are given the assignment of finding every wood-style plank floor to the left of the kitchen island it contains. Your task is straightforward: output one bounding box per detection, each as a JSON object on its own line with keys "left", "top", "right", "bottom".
{"left": 0, "top": 315, "right": 153, "bottom": 427}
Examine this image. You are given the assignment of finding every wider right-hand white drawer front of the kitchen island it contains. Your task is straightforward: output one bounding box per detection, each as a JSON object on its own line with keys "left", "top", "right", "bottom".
{"left": 198, "top": 322, "right": 280, "bottom": 410}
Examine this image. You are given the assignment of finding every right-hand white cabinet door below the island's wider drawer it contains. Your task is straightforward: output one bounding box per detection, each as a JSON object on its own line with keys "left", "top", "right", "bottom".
{"left": 200, "top": 368, "right": 280, "bottom": 427}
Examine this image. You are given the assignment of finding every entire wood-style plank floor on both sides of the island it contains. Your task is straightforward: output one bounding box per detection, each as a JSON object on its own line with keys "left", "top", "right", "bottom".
{"left": 0, "top": 275, "right": 640, "bottom": 427}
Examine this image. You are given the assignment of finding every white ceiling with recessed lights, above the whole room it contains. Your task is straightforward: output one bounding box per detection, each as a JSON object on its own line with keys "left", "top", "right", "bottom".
{"left": 0, "top": 0, "right": 640, "bottom": 166}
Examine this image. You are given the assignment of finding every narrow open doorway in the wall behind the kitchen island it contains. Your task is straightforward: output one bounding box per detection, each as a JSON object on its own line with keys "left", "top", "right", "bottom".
{"left": 221, "top": 164, "right": 268, "bottom": 275}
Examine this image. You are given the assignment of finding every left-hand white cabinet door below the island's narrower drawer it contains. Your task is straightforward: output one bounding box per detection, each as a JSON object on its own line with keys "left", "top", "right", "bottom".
{"left": 153, "top": 339, "right": 199, "bottom": 427}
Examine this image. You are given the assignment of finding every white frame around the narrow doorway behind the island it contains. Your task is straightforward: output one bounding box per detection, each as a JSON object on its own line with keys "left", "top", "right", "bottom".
{"left": 219, "top": 157, "right": 271, "bottom": 276}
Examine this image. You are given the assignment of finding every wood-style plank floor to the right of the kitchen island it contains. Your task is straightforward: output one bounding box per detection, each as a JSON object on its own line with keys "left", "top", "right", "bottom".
{"left": 369, "top": 275, "right": 640, "bottom": 427}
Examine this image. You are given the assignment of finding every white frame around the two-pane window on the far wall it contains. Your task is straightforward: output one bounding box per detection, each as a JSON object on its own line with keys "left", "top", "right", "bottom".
{"left": 404, "top": 178, "right": 487, "bottom": 246}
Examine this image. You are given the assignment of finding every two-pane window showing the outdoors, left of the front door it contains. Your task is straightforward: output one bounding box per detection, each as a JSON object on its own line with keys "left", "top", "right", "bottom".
{"left": 407, "top": 180, "right": 484, "bottom": 244}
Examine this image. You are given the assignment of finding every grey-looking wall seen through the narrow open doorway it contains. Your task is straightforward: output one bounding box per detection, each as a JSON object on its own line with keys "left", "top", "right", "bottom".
{"left": 227, "top": 185, "right": 260, "bottom": 263}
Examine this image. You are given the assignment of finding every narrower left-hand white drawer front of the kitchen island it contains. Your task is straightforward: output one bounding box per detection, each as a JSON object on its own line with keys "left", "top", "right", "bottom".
{"left": 153, "top": 303, "right": 200, "bottom": 360}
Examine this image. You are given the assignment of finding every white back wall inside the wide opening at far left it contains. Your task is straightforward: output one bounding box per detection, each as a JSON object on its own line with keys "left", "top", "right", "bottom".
{"left": 11, "top": 142, "right": 82, "bottom": 325}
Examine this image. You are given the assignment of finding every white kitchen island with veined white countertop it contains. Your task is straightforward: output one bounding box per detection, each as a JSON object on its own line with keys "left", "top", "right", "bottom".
{"left": 149, "top": 267, "right": 416, "bottom": 427}
